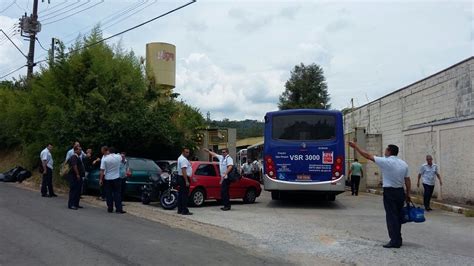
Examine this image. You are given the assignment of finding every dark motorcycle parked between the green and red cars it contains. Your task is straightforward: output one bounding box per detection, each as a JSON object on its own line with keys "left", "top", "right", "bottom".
{"left": 141, "top": 172, "right": 178, "bottom": 210}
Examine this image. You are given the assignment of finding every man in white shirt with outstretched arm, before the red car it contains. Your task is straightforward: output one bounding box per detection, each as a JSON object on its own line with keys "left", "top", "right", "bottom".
{"left": 204, "top": 148, "right": 234, "bottom": 211}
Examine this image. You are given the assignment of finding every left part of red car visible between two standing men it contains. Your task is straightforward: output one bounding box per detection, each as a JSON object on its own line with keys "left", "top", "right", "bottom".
{"left": 193, "top": 162, "right": 220, "bottom": 199}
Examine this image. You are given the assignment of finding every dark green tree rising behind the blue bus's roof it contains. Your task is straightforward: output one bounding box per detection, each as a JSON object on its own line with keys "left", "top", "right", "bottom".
{"left": 278, "top": 63, "right": 331, "bottom": 110}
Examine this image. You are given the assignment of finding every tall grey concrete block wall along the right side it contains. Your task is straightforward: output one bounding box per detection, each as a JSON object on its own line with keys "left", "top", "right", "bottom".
{"left": 344, "top": 57, "right": 474, "bottom": 202}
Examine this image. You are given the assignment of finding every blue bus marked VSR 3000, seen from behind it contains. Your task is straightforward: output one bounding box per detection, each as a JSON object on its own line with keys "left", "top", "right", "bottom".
{"left": 263, "top": 109, "right": 345, "bottom": 201}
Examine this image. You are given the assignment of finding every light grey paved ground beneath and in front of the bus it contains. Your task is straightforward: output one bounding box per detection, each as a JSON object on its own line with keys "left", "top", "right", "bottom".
{"left": 139, "top": 188, "right": 474, "bottom": 265}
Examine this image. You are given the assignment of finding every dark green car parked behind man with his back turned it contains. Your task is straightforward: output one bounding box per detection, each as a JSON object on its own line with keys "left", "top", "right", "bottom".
{"left": 84, "top": 157, "right": 161, "bottom": 198}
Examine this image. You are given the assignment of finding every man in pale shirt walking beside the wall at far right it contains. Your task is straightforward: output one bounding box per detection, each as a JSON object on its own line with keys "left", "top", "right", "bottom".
{"left": 416, "top": 155, "right": 443, "bottom": 211}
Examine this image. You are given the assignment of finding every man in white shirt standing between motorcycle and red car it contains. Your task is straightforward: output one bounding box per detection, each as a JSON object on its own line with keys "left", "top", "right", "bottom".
{"left": 177, "top": 148, "right": 193, "bottom": 215}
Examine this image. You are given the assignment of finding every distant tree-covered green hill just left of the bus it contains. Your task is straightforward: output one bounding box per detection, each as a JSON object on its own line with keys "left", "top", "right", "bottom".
{"left": 209, "top": 119, "right": 265, "bottom": 139}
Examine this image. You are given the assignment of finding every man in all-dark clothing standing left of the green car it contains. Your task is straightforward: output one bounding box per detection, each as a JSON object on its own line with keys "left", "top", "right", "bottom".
{"left": 68, "top": 146, "right": 86, "bottom": 210}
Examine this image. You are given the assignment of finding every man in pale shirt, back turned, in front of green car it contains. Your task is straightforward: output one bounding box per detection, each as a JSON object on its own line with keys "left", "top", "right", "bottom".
{"left": 99, "top": 146, "right": 126, "bottom": 213}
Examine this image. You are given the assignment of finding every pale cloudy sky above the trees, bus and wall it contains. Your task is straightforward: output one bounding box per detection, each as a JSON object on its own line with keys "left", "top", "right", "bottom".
{"left": 0, "top": 0, "right": 474, "bottom": 120}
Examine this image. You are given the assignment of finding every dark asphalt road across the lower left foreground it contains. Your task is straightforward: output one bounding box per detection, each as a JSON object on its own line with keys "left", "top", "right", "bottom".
{"left": 0, "top": 183, "right": 278, "bottom": 265}
